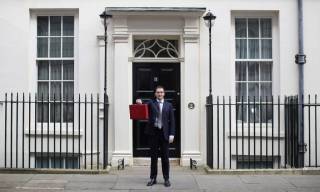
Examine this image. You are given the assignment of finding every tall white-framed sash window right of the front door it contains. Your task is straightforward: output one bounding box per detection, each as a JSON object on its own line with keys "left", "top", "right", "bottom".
{"left": 235, "top": 18, "right": 273, "bottom": 122}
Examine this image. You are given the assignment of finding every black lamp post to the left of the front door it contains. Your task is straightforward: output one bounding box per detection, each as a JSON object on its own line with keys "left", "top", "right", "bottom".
{"left": 98, "top": 10, "right": 112, "bottom": 169}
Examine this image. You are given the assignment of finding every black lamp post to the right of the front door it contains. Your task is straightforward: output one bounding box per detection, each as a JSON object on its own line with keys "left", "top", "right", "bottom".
{"left": 203, "top": 11, "right": 216, "bottom": 169}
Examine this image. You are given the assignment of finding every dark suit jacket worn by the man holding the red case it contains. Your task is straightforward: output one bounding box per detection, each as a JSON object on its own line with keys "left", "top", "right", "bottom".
{"left": 145, "top": 98, "right": 175, "bottom": 140}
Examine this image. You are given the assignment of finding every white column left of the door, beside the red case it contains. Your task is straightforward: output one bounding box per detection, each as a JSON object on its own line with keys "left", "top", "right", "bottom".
{"left": 111, "top": 16, "right": 133, "bottom": 166}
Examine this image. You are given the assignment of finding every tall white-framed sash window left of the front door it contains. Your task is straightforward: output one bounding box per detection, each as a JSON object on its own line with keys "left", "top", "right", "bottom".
{"left": 36, "top": 16, "right": 74, "bottom": 122}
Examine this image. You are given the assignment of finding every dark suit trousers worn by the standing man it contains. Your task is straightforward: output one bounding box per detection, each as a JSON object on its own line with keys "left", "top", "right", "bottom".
{"left": 149, "top": 127, "right": 169, "bottom": 180}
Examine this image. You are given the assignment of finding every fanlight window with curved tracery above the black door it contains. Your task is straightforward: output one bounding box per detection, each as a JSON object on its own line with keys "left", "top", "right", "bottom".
{"left": 133, "top": 39, "right": 179, "bottom": 58}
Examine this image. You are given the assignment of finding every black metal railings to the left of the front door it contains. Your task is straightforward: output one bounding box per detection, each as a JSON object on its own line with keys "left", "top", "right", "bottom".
{"left": 0, "top": 93, "right": 109, "bottom": 169}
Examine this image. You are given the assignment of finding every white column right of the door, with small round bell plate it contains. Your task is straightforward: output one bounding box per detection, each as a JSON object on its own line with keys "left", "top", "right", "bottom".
{"left": 180, "top": 17, "right": 202, "bottom": 166}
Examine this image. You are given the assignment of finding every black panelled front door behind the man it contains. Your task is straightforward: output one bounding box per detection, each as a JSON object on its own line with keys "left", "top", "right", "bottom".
{"left": 132, "top": 63, "right": 180, "bottom": 157}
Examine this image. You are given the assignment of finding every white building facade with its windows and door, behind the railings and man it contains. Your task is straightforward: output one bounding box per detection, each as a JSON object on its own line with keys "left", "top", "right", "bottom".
{"left": 0, "top": 0, "right": 320, "bottom": 167}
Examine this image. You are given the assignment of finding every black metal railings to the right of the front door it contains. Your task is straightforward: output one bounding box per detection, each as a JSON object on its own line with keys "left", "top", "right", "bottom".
{"left": 206, "top": 95, "right": 320, "bottom": 169}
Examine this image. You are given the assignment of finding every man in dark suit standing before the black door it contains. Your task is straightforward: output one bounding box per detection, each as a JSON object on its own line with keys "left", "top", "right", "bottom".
{"left": 136, "top": 85, "right": 175, "bottom": 187}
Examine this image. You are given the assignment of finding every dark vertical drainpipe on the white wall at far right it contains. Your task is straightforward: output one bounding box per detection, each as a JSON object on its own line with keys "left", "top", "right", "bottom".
{"left": 295, "top": 0, "right": 306, "bottom": 167}
